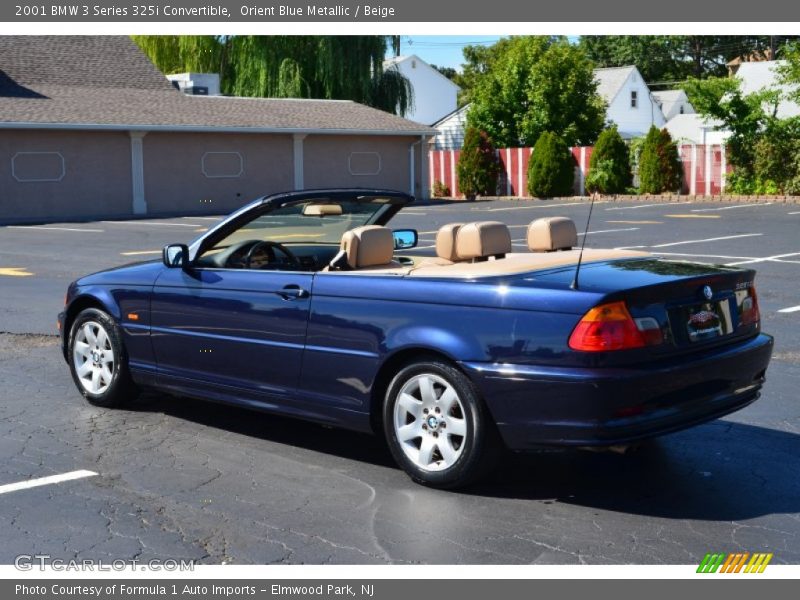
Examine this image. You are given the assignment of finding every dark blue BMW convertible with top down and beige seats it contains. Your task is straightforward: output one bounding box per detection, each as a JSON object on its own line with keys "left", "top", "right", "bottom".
{"left": 59, "top": 189, "right": 772, "bottom": 488}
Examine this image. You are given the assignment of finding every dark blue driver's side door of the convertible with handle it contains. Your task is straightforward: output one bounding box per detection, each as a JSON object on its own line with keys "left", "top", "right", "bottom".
{"left": 151, "top": 267, "right": 313, "bottom": 401}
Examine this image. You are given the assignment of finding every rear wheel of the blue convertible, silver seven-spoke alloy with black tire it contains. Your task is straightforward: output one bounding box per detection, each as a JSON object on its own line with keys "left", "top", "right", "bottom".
{"left": 383, "top": 361, "right": 500, "bottom": 489}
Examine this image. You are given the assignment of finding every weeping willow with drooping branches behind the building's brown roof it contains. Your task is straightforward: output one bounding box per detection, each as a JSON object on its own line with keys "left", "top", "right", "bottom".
{"left": 132, "top": 35, "right": 414, "bottom": 115}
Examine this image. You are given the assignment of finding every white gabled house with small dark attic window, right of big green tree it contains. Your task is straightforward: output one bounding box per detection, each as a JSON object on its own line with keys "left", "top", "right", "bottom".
{"left": 594, "top": 66, "right": 666, "bottom": 139}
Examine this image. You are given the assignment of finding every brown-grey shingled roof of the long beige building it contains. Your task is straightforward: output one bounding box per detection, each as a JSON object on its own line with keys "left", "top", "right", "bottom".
{"left": 0, "top": 36, "right": 435, "bottom": 135}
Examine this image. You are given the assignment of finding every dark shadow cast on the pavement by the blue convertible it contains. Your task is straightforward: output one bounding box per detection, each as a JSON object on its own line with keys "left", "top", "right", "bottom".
{"left": 130, "top": 394, "right": 800, "bottom": 521}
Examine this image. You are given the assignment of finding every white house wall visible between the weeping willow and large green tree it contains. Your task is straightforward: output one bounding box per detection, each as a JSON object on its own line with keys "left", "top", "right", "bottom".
{"left": 383, "top": 54, "right": 461, "bottom": 125}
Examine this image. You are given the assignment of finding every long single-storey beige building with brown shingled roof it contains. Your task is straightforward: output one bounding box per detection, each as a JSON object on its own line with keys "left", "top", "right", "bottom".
{"left": 0, "top": 36, "right": 435, "bottom": 223}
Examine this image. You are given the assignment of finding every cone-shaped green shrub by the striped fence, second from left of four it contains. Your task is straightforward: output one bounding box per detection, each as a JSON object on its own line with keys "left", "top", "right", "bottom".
{"left": 528, "top": 131, "right": 575, "bottom": 198}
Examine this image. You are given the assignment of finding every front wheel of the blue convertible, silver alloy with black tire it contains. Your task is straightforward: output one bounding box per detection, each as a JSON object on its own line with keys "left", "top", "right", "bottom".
{"left": 68, "top": 308, "right": 139, "bottom": 408}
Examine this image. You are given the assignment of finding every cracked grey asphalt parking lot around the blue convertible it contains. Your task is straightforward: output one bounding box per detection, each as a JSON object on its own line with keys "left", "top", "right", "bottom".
{"left": 0, "top": 200, "right": 800, "bottom": 564}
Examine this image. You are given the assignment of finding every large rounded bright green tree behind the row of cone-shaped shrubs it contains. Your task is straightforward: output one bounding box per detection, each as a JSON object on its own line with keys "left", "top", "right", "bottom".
{"left": 467, "top": 36, "right": 605, "bottom": 147}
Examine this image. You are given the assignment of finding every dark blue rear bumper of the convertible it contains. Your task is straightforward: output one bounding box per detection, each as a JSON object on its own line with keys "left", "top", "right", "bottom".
{"left": 462, "top": 334, "right": 773, "bottom": 450}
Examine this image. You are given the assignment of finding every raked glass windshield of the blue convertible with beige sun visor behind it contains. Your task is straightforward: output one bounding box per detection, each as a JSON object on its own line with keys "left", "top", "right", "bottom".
{"left": 207, "top": 198, "right": 390, "bottom": 253}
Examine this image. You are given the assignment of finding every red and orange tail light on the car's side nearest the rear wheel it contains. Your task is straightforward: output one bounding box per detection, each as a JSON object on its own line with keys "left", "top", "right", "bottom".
{"left": 569, "top": 302, "right": 664, "bottom": 352}
